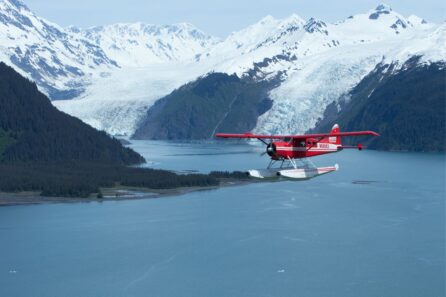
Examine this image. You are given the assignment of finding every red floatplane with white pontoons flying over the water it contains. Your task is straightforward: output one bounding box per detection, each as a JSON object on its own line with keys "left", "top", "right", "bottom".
{"left": 215, "top": 124, "right": 379, "bottom": 180}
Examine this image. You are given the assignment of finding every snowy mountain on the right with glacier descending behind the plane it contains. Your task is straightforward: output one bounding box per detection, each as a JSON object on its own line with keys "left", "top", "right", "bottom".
{"left": 129, "top": 5, "right": 446, "bottom": 134}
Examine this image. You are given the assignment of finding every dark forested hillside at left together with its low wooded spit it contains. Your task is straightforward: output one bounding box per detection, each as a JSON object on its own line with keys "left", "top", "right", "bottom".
{"left": 0, "top": 63, "right": 222, "bottom": 197}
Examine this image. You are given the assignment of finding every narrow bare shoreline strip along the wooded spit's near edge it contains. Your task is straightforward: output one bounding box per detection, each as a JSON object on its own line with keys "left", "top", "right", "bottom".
{"left": 0, "top": 179, "right": 254, "bottom": 207}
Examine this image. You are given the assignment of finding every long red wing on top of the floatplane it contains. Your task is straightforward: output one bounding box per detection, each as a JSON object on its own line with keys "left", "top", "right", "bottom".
{"left": 215, "top": 131, "right": 379, "bottom": 139}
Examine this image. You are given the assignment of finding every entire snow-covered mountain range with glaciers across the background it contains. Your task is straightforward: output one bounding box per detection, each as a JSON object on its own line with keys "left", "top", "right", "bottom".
{"left": 0, "top": 0, "right": 446, "bottom": 149}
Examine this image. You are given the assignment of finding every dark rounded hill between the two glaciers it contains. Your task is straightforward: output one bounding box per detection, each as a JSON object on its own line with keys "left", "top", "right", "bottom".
{"left": 133, "top": 73, "right": 277, "bottom": 139}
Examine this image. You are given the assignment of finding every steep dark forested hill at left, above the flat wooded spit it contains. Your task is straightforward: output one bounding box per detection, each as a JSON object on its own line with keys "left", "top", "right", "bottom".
{"left": 0, "top": 63, "right": 144, "bottom": 165}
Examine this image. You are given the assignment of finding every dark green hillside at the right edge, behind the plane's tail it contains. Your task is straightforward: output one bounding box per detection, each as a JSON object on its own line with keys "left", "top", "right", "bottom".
{"left": 316, "top": 58, "right": 446, "bottom": 151}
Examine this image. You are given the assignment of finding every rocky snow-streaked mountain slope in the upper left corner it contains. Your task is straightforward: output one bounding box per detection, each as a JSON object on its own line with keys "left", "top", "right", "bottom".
{"left": 0, "top": 0, "right": 117, "bottom": 99}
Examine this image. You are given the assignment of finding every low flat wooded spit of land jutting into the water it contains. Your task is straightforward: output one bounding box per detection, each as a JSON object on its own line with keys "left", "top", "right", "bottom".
{"left": 0, "top": 164, "right": 251, "bottom": 206}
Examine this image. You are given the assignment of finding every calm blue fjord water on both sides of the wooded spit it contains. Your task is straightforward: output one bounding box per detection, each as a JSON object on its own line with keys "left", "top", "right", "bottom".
{"left": 0, "top": 141, "right": 445, "bottom": 297}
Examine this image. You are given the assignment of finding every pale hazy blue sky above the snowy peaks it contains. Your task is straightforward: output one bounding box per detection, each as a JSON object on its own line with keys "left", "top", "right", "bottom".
{"left": 23, "top": 0, "right": 446, "bottom": 37}
